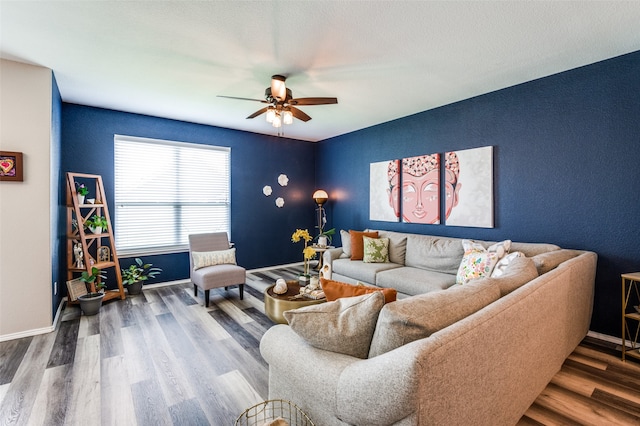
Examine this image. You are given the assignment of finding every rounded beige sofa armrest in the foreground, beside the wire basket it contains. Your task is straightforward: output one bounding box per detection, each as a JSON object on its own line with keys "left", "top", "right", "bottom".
{"left": 260, "top": 325, "right": 419, "bottom": 426}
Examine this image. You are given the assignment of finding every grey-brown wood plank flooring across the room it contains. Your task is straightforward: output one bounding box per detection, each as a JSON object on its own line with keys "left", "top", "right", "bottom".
{"left": 0, "top": 267, "right": 640, "bottom": 426}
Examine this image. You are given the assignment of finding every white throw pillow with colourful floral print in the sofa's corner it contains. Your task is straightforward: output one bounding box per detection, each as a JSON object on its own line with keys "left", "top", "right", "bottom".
{"left": 456, "top": 240, "right": 511, "bottom": 284}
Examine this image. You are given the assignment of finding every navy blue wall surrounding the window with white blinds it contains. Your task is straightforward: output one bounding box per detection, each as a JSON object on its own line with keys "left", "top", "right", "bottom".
{"left": 61, "top": 103, "right": 315, "bottom": 288}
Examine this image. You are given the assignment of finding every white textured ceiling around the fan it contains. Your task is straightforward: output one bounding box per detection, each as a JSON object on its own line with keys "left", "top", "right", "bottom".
{"left": 0, "top": 0, "right": 640, "bottom": 141}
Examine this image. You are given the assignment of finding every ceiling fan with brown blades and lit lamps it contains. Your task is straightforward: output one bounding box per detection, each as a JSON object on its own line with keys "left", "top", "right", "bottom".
{"left": 218, "top": 75, "right": 338, "bottom": 127}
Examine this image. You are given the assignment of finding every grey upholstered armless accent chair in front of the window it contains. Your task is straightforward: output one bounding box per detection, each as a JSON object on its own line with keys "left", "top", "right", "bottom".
{"left": 189, "top": 232, "right": 247, "bottom": 307}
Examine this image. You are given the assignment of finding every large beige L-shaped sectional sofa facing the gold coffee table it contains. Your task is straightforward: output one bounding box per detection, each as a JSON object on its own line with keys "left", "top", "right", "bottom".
{"left": 260, "top": 232, "right": 597, "bottom": 426}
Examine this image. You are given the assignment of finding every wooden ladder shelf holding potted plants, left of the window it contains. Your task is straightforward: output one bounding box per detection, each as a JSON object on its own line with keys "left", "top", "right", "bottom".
{"left": 67, "top": 172, "right": 125, "bottom": 304}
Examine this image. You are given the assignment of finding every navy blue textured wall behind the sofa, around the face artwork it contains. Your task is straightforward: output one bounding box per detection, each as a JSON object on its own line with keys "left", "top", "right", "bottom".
{"left": 316, "top": 52, "right": 640, "bottom": 336}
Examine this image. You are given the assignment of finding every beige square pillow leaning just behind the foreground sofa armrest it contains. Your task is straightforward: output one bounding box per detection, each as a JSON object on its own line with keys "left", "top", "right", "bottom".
{"left": 284, "top": 291, "right": 384, "bottom": 358}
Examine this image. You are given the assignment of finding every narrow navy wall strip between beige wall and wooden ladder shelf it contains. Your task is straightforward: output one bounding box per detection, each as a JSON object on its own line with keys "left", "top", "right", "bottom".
{"left": 50, "top": 72, "right": 66, "bottom": 318}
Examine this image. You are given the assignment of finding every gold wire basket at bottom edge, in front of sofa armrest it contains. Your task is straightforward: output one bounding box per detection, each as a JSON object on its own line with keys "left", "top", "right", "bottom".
{"left": 235, "top": 399, "right": 315, "bottom": 426}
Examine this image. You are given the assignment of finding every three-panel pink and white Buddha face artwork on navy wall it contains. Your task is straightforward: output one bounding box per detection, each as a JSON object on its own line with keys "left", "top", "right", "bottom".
{"left": 369, "top": 146, "right": 493, "bottom": 228}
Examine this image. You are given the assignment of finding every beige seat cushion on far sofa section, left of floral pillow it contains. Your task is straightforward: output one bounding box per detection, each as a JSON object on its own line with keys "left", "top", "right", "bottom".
{"left": 375, "top": 266, "right": 456, "bottom": 296}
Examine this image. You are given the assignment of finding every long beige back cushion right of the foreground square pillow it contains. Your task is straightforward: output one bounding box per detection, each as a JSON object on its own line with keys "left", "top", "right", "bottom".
{"left": 369, "top": 281, "right": 500, "bottom": 358}
